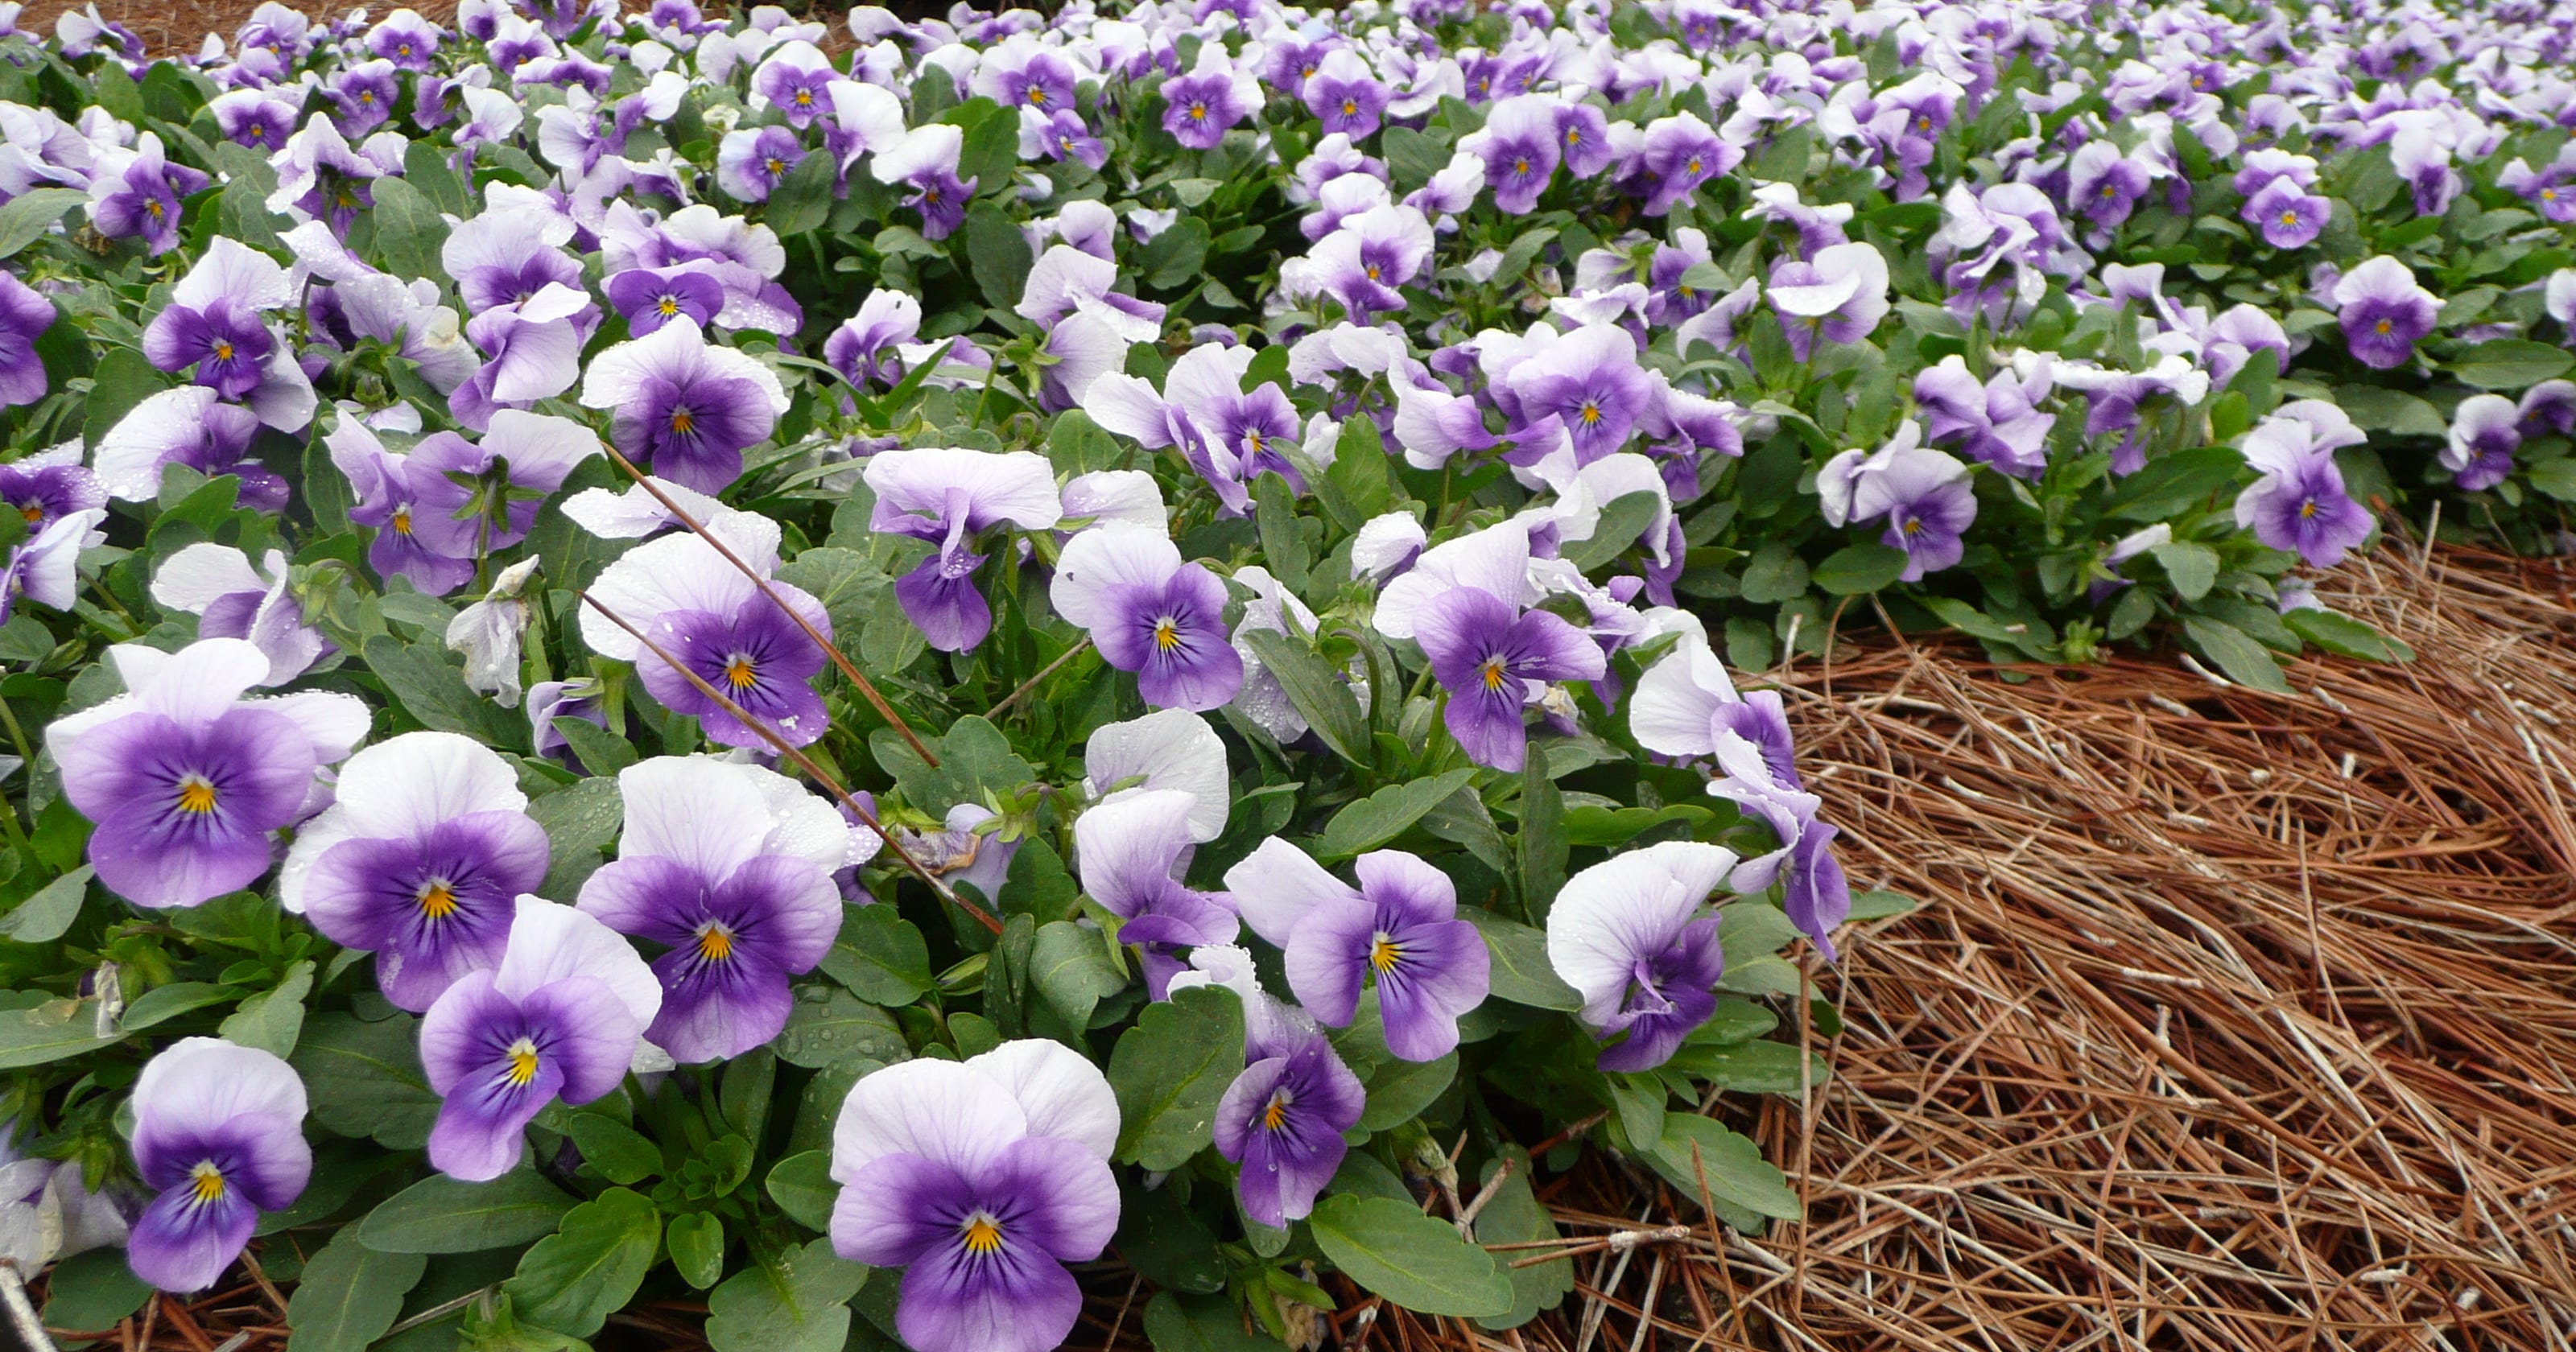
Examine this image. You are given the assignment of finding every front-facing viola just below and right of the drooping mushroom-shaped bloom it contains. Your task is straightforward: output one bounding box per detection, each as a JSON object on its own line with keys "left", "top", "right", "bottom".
{"left": 1048, "top": 523, "right": 1245, "bottom": 711}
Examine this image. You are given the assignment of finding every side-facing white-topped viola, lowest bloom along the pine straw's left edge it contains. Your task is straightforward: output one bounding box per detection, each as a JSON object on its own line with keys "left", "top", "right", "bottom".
{"left": 1548, "top": 839, "right": 1736, "bottom": 1071}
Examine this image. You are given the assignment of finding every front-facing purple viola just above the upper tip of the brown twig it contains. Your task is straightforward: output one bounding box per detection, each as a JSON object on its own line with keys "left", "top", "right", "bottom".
{"left": 582, "top": 319, "right": 788, "bottom": 492}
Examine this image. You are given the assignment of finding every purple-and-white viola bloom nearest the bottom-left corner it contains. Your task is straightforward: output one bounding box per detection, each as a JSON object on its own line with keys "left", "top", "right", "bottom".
{"left": 126, "top": 1038, "right": 314, "bottom": 1292}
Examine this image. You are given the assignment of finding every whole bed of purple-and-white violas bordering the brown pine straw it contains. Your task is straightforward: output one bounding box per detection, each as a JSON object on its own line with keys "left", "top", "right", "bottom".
{"left": 0, "top": 0, "right": 2576, "bottom": 1352}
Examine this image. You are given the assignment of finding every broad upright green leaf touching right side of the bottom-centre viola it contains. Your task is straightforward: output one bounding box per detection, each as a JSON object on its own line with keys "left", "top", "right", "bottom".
{"left": 1110, "top": 987, "right": 1245, "bottom": 1169}
